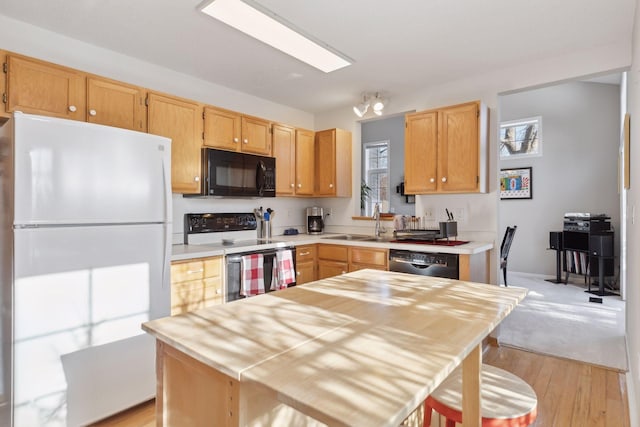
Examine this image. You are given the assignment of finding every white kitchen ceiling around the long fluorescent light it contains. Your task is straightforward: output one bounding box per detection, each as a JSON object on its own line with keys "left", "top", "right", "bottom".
{"left": 0, "top": 0, "right": 635, "bottom": 113}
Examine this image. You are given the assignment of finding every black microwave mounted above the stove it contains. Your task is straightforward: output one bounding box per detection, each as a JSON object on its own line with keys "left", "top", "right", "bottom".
{"left": 202, "top": 148, "right": 276, "bottom": 197}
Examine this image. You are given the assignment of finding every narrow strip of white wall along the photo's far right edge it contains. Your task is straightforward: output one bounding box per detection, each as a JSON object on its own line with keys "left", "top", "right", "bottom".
{"left": 625, "top": 0, "right": 640, "bottom": 427}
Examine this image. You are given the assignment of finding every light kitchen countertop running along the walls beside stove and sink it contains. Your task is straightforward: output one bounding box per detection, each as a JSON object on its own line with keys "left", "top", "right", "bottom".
{"left": 171, "top": 233, "right": 493, "bottom": 261}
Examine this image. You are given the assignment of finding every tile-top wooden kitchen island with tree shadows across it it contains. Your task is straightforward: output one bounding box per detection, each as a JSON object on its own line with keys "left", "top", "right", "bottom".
{"left": 143, "top": 270, "right": 526, "bottom": 426}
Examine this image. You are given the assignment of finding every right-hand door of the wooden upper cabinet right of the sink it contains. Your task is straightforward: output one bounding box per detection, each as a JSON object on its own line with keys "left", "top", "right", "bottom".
{"left": 440, "top": 102, "right": 480, "bottom": 192}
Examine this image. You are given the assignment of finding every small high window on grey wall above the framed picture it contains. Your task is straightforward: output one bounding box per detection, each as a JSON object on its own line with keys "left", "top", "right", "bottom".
{"left": 500, "top": 117, "right": 542, "bottom": 158}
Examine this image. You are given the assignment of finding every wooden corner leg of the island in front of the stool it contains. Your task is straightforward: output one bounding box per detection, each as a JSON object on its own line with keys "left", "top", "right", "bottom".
{"left": 462, "top": 345, "right": 482, "bottom": 427}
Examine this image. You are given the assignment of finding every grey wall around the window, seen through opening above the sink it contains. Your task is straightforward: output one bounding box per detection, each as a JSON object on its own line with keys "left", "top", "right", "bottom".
{"left": 361, "top": 115, "right": 414, "bottom": 215}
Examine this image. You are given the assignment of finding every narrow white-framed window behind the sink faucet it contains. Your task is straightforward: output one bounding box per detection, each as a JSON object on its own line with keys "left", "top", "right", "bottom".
{"left": 363, "top": 141, "right": 390, "bottom": 215}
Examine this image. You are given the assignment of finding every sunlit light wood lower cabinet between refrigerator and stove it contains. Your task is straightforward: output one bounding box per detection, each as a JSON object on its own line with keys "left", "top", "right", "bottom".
{"left": 171, "top": 257, "right": 223, "bottom": 316}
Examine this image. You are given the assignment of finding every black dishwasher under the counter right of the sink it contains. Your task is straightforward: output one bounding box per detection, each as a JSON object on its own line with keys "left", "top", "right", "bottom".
{"left": 389, "top": 249, "right": 459, "bottom": 279}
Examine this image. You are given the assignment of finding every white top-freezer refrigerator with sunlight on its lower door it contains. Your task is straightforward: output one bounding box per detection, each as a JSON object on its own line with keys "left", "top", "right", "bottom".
{"left": 0, "top": 113, "right": 171, "bottom": 427}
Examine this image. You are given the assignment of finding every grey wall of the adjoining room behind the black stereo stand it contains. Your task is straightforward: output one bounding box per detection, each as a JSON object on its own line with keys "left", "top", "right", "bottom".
{"left": 498, "top": 82, "right": 620, "bottom": 277}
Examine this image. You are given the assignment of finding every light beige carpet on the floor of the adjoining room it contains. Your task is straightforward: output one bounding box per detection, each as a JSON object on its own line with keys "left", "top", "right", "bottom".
{"left": 498, "top": 272, "right": 627, "bottom": 371}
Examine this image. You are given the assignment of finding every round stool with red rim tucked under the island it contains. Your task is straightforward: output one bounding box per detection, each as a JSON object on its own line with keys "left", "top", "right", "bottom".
{"left": 424, "top": 364, "right": 538, "bottom": 427}
